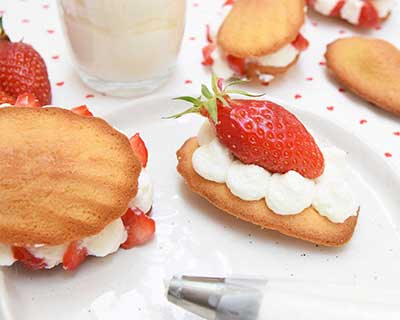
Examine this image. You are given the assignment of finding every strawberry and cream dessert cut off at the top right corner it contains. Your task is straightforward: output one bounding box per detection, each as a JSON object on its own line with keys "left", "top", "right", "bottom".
{"left": 307, "top": 0, "right": 396, "bottom": 28}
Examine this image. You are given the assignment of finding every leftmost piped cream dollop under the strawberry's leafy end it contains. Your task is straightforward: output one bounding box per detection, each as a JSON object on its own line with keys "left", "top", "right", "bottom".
{"left": 192, "top": 139, "right": 233, "bottom": 183}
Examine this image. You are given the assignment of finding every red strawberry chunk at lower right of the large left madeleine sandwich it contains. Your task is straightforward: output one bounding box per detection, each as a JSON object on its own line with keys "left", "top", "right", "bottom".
{"left": 121, "top": 208, "right": 156, "bottom": 249}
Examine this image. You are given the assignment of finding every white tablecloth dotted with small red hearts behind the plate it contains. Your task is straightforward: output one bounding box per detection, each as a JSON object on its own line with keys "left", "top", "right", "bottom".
{"left": 0, "top": 0, "right": 400, "bottom": 171}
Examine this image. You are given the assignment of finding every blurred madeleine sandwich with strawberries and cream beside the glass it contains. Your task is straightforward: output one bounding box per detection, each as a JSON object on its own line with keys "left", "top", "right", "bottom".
{"left": 202, "top": 0, "right": 308, "bottom": 84}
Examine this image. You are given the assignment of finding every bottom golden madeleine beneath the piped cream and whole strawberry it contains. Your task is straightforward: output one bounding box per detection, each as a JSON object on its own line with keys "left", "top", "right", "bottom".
{"left": 177, "top": 138, "right": 358, "bottom": 247}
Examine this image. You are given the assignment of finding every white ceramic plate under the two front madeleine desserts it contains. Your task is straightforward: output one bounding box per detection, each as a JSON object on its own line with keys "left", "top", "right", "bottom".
{"left": 0, "top": 98, "right": 400, "bottom": 320}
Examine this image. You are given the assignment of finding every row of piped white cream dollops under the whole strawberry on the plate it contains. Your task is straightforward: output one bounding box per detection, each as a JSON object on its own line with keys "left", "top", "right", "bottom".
{"left": 192, "top": 120, "right": 358, "bottom": 223}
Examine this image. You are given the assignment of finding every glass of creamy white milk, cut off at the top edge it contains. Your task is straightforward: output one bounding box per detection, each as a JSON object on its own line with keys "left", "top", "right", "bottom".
{"left": 58, "top": 0, "right": 185, "bottom": 97}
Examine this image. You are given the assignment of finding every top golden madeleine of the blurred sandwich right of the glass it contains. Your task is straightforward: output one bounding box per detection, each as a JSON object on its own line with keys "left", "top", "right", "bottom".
{"left": 217, "top": 0, "right": 305, "bottom": 58}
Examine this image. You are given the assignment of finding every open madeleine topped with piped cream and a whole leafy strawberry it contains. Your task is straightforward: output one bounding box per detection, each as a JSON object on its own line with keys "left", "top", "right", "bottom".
{"left": 174, "top": 77, "right": 359, "bottom": 247}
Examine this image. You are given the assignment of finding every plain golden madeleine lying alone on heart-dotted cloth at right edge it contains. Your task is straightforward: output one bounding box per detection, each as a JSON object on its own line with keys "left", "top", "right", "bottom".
{"left": 325, "top": 37, "right": 400, "bottom": 115}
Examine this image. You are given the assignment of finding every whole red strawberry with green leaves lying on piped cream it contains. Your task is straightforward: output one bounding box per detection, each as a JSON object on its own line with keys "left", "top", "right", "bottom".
{"left": 174, "top": 76, "right": 324, "bottom": 179}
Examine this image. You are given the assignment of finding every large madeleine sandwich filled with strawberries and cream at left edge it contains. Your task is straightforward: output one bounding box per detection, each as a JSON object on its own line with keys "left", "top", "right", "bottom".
{"left": 0, "top": 102, "right": 155, "bottom": 270}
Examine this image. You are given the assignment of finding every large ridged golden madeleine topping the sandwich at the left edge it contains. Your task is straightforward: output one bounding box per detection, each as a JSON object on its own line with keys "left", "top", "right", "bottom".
{"left": 0, "top": 107, "right": 141, "bottom": 246}
